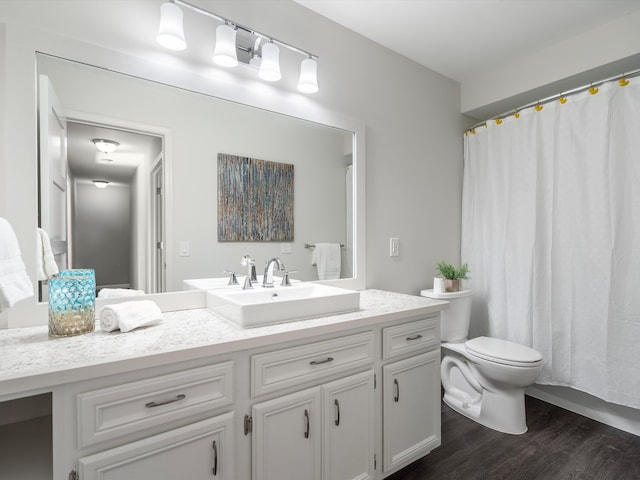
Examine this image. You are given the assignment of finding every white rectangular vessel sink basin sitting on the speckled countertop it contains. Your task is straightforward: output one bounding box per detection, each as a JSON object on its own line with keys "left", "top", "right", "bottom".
{"left": 207, "top": 282, "right": 360, "bottom": 328}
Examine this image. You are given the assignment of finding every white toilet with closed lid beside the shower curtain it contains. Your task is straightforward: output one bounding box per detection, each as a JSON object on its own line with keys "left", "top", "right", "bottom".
{"left": 420, "top": 290, "right": 542, "bottom": 434}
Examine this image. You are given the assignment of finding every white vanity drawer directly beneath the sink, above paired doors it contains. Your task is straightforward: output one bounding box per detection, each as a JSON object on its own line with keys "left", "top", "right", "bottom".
{"left": 251, "top": 332, "right": 374, "bottom": 396}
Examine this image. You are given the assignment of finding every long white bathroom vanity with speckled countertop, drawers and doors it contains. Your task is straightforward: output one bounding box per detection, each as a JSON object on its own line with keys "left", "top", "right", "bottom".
{"left": 0, "top": 290, "right": 447, "bottom": 480}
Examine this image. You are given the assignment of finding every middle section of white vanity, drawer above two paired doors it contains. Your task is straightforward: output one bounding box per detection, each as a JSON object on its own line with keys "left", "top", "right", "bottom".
{"left": 251, "top": 331, "right": 376, "bottom": 480}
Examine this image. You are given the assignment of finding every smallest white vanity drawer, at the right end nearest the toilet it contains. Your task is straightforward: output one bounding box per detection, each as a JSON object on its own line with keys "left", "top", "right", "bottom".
{"left": 382, "top": 315, "right": 440, "bottom": 360}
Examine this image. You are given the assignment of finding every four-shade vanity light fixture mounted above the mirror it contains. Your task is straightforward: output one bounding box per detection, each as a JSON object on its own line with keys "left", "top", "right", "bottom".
{"left": 156, "top": 0, "right": 319, "bottom": 93}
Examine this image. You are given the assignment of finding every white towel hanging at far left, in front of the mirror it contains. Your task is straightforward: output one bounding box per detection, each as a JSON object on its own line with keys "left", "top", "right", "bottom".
{"left": 0, "top": 218, "right": 33, "bottom": 313}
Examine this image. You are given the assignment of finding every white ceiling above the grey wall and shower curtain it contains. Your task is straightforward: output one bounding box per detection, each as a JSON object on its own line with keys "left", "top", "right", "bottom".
{"left": 294, "top": 0, "right": 640, "bottom": 83}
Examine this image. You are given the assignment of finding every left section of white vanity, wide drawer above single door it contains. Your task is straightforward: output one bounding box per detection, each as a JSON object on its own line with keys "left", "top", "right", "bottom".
{"left": 63, "top": 361, "right": 236, "bottom": 480}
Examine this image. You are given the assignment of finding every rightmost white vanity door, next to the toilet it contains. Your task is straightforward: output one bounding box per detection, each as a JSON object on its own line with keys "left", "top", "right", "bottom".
{"left": 383, "top": 349, "right": 441, "bottom": 473}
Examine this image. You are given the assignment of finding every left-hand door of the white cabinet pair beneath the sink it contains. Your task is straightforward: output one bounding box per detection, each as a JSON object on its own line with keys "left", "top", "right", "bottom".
{"left": 253, "top": 387, "right": 322, "bottom": 480}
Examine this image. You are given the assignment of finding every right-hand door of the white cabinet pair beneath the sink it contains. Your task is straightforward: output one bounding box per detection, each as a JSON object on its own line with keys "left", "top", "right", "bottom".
{"left": 322, "top": 370, "right": 375, "bottom": 480}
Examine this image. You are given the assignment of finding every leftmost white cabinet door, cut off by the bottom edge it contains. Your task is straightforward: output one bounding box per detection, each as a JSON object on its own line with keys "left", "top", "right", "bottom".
{"left": 78, "top": 413, "right": 235, "bottom": 480}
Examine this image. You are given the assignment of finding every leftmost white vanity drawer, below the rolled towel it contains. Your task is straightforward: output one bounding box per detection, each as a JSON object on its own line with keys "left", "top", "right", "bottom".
{"left": 77, "top": 362, "right": 233, "bottom": 448}
